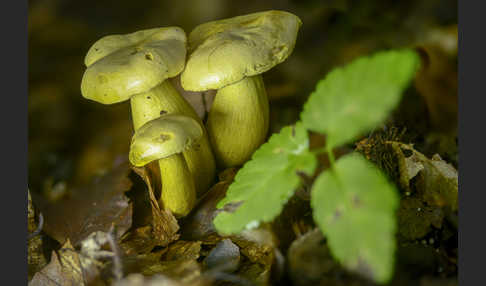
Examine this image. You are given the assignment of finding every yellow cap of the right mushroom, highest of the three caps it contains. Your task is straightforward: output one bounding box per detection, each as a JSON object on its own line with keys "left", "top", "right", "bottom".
{"left": 181, "top": 11, "right": 302, "bottom": 91}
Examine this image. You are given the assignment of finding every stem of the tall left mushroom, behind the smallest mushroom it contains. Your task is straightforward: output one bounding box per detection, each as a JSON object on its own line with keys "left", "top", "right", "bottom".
{"left": 130, "top": 80, "right": 216, "bottom": 195}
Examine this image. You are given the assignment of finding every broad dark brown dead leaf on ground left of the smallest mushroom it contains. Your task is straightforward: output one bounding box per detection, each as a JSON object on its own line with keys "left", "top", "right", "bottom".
{"left": 34, "top": 160, "right": 132, "bottom": 245}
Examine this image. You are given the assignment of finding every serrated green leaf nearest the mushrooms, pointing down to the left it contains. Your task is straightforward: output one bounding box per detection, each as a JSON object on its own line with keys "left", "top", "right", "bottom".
{"left": 213, "top": 122, "right": 317, "bottom": 234}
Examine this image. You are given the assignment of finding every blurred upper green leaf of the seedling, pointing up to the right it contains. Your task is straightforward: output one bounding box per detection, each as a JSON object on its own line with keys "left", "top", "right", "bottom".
{"left": 301, "top": 50, "right": 420, "bottom": 147}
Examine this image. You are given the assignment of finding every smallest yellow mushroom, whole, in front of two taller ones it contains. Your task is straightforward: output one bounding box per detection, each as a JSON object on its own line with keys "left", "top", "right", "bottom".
{"left": 128, "top": 114, "right": 203, "bottom": 217}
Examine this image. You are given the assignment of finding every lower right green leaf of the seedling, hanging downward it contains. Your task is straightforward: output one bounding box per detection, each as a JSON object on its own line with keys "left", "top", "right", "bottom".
{"left": 311, "top": 153, "right": 399, "bottom": 283}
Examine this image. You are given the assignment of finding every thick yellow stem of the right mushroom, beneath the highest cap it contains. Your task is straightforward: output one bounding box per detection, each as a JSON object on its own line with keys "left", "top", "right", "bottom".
{"left": 206, "top": 75, "right": 269, "bottom": 168}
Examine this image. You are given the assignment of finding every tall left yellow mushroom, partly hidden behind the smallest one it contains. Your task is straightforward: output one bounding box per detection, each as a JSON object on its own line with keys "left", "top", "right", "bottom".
{"left": 81, "top": 27, "right": 215, "bottom": 197}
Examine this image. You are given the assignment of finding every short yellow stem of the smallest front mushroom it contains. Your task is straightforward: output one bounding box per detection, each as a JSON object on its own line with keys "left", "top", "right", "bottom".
{"left": 159, "top": 153, "right": 196, "bottom": 217}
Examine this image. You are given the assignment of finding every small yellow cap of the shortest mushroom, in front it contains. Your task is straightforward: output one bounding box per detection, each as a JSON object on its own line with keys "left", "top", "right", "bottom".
{"left": 128, "top": 114, "right": 203, "bottom": 166}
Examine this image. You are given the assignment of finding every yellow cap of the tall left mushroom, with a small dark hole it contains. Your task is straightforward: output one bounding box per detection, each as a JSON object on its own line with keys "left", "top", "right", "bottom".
{"left": 81, "top": 27, "right": 186, "bottom": 104}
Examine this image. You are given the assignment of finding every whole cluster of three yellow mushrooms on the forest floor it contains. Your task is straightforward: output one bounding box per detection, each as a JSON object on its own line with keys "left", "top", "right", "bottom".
{"left": 81, "top": 11, "right": 301, "bottom": 217}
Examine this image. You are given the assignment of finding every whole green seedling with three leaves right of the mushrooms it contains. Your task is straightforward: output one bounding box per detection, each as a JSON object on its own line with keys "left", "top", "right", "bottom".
{"left": 213, "top": 50, "right": 419, "bottom": 283}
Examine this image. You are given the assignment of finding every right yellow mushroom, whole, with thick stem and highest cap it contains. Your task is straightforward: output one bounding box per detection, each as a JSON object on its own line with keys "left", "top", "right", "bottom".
{"left": 181, "top": 11, "right": 302, "bottom": 167}
